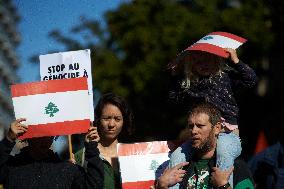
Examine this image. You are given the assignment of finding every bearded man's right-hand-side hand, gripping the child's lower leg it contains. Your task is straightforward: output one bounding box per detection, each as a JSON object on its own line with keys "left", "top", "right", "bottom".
{"left": 210, "top": 167, "right": 234, "bottom": 188}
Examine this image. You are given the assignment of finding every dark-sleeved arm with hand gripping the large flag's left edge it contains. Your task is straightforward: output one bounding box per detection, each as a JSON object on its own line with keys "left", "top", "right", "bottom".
{"left": 0, "top": 118, "right": 27, "bottom": 183}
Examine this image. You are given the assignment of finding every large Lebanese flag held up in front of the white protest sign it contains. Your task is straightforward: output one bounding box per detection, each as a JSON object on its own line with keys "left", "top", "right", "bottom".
{"left": 11, "top": 77, "right": 90, "bottom": 140}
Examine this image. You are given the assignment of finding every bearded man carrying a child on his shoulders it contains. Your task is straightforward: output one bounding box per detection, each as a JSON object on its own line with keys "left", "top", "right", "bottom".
{"left": 156, "top": 103, "right": 254, "bottom": 189}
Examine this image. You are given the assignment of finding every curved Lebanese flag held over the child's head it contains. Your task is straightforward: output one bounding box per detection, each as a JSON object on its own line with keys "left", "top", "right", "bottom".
{"left": 183, "top": 32, "right": 247, "bottom": 58}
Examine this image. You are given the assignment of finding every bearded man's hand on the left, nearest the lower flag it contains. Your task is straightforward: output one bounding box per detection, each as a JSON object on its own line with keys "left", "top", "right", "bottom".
{"left": 156, "top": 162, "right": 189, "bottom": 189}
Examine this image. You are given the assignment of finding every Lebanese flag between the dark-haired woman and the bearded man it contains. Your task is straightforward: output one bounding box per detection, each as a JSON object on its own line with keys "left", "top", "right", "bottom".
{"left": 117, "top": 141, "right": 178, "bottom": 189}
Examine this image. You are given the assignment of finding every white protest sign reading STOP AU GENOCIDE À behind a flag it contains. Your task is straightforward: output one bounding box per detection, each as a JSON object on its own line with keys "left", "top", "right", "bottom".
{"left": 39, "top": 49, "right": 94, "bottom": 121}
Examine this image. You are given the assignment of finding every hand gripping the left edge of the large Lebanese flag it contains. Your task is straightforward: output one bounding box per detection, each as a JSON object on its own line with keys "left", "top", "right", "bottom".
{"left": 7, "top": 118, "right": 28, "bottom": 142}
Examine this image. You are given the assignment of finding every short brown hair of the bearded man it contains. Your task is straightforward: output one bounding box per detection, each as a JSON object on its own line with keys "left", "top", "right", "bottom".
{"left": 188, "top": 102, "right": 221, "bottom": 126}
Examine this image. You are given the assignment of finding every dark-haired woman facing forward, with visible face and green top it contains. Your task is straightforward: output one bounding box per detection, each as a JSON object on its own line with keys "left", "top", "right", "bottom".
{"left": 75, "top": 93, "right": 133, "bottom": 189}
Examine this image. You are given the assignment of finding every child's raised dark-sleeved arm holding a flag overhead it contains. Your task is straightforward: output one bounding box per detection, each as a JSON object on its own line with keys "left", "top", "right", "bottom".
{"left": 225, "top": 48, "right": 257, "bottom": 88}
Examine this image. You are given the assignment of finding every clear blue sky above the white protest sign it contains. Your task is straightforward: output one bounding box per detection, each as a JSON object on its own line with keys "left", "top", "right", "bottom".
{"left": 13, "top": 0, "right": 125, "bottom": 83}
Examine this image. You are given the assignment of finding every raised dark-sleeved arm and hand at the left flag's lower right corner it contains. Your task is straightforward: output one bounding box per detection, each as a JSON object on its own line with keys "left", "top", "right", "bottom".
{"left": 72, "top": 127, "right": 104, "bottom": 189}
